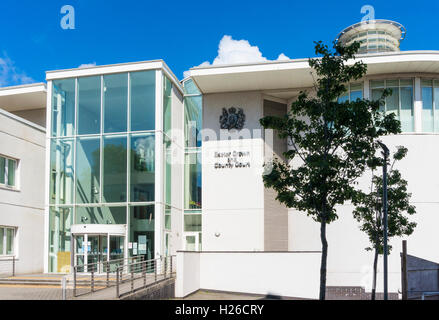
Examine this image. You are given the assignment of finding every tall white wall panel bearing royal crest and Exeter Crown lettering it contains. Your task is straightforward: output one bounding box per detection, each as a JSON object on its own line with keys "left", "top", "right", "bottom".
{"left": 202, "top": 93, "right": 264, "bottom": 251}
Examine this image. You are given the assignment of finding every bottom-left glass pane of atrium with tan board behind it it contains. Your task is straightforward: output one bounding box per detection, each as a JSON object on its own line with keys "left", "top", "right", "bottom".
{"left": 49, "top": 207, "right": 73, "bottom": 273}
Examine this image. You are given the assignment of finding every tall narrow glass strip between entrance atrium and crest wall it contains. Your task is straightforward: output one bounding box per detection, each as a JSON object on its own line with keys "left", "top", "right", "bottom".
{"left": 183, "top": 80, "right": 203, "bottom": 250}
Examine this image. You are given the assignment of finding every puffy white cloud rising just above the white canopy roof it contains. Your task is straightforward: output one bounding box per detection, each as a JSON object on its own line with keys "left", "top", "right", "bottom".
{"left": 184, "top": 35, "right": 290, "bottom": 78}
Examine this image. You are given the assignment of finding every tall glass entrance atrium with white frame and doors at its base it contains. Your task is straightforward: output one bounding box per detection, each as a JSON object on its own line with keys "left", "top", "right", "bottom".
{"left": 48, "top": 69, "right": 179, "bottom": 272}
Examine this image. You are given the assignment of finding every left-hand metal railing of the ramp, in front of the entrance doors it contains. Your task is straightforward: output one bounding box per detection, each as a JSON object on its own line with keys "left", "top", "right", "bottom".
{"left": 72, "top": 256, "right": 144, "bottom": 297}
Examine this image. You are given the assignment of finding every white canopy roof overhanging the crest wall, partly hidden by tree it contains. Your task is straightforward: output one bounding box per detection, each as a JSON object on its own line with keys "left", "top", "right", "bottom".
{"left": 190, "top": 51, "right": 439, "bottom": 99}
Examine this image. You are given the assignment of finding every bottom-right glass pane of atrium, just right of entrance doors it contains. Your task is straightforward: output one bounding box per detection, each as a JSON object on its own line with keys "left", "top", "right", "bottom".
{"left": 129, "top": 205, "right": 155, "bottom": 260}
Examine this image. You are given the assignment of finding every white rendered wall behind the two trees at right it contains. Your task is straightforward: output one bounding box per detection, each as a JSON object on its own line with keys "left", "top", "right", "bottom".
{"left": 289, "top": 134, "right": 439, "bottom": 292}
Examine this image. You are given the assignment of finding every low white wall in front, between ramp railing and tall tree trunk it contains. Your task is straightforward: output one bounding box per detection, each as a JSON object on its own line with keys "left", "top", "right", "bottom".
{"left": 175, "top": 252, "right": 320, "bottom": 299}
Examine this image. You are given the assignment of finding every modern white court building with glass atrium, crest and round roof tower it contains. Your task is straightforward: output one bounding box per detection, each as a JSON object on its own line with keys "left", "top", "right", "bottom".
{"left": 0, "top": 20, "right": 439, "bottom": 298}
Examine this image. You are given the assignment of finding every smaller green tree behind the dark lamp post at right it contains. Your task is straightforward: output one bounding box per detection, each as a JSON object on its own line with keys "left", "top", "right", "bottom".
{"left": 353, "top": 146, "right": 416, "bottom": 300}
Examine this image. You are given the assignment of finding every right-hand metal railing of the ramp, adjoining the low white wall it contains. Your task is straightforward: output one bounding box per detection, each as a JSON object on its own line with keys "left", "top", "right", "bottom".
{"left": 116, "top": 256, "right": 176, "bottom": 299}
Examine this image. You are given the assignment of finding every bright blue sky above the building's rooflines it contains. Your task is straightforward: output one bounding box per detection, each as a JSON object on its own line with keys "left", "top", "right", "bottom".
{"left": 0, "top": 0, "right": 439, "bottom": 86}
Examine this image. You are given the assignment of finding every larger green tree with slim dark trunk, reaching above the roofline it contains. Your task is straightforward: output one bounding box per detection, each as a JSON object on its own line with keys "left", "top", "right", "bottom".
{"left": 260, "top": 41, "right": 401, "bottom": 300}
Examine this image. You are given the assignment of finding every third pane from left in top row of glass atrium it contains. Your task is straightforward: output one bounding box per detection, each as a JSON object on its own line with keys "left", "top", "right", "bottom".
{"left": 104, "top": 73, "right": 128, "bottom": 132}
